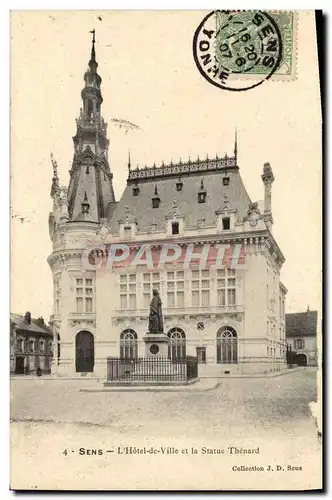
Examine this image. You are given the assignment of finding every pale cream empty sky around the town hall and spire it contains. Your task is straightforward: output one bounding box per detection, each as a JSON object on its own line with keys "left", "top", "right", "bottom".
{"left": 11, "top": 11, "right": 322, "bottom": 319}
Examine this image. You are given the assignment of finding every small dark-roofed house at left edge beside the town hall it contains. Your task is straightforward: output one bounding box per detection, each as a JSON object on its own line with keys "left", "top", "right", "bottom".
{"left": 10, "top": 312, "right": 53, "bottom": 374}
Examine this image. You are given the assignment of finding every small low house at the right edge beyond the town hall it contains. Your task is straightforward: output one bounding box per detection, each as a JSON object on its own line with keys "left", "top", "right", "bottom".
{"left": 286, "top": 306, "right": 317, "bottom": 366}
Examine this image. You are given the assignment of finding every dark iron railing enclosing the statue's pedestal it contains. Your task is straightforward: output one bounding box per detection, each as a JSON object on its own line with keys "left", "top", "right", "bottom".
{"left": 107, "top": 357, "right": 198, "bottom": 382}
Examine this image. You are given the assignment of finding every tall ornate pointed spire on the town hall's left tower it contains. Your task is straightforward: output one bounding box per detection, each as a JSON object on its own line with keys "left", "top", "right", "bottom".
{"left": 68, "top": 29, "right": 115, "bottom": 222}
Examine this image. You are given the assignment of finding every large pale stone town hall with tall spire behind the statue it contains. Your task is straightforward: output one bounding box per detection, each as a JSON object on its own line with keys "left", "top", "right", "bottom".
{"left": 48, "top": 35, "right": 287, "bottom": 377}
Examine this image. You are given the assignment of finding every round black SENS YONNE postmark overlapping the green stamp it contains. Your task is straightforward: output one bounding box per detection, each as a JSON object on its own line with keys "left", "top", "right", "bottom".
{"left": 193, "top": 10, "right": 282, "bottom": 91}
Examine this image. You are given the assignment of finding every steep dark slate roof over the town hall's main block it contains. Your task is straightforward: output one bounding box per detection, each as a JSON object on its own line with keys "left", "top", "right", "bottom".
{"left": 110, "top": 164, "right": 251, "bottom": 231}
